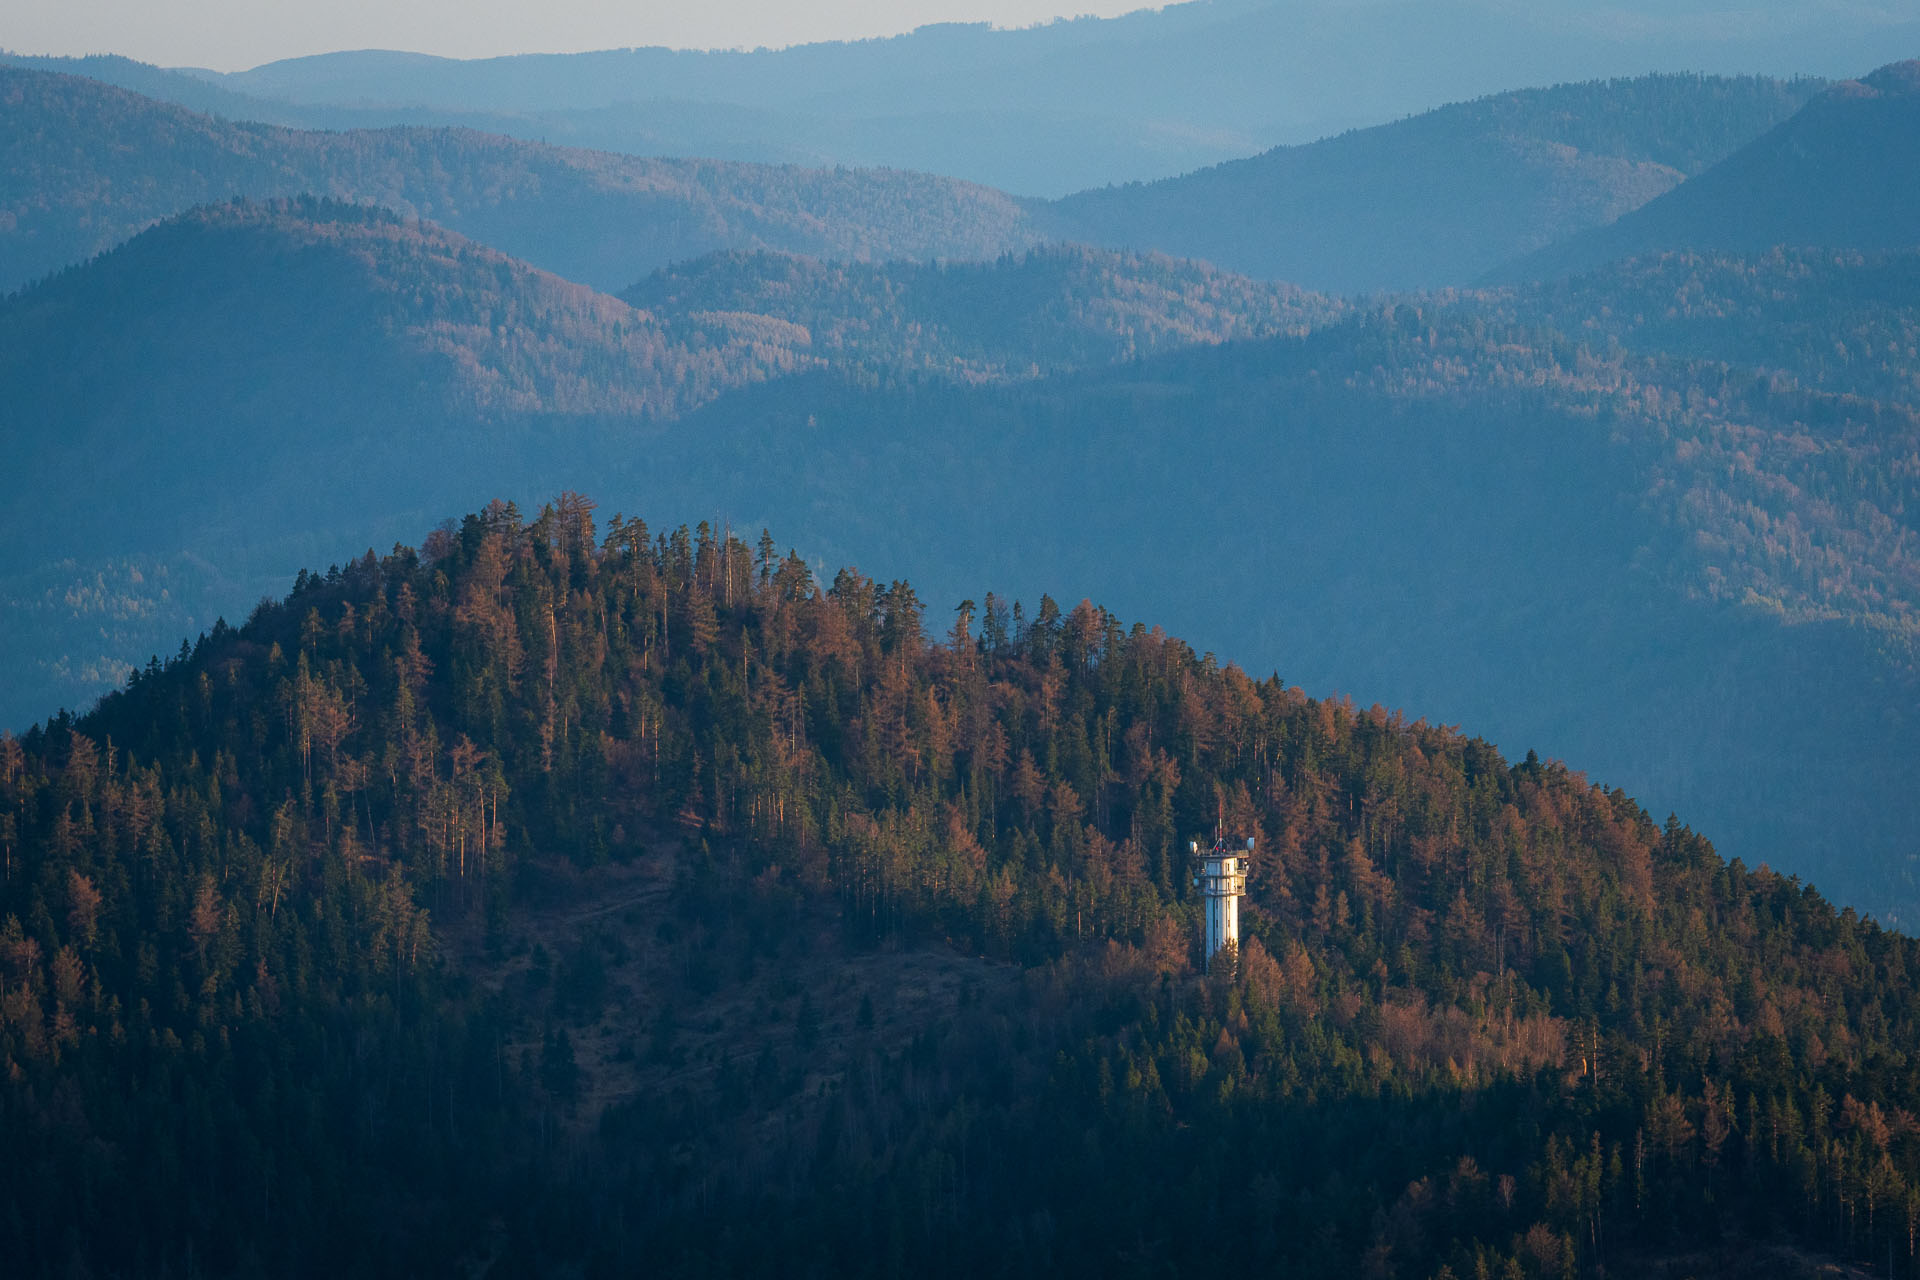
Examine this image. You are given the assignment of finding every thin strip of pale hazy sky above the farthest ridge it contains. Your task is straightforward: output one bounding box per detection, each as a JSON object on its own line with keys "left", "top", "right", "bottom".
{"left": 0, "top": 0, "right": 1150, "bottom": 71}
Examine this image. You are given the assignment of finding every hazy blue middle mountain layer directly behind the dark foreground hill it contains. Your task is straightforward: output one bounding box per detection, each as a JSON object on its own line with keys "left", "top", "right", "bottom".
{"left": 0, "top": 188, "right": 1920, "bottom": 932}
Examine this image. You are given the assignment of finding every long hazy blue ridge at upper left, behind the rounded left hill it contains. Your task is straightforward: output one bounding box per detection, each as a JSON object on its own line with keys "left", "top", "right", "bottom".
{"left": 0, "top": 67, "right": 1037, "bottom": 292}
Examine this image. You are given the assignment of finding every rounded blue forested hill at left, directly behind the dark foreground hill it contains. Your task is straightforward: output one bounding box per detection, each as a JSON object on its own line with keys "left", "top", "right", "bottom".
{"left": 0, "top": 201, "right": 808, "bottom": 718}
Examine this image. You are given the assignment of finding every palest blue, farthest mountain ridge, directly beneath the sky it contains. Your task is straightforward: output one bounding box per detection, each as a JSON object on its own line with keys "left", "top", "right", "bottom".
{"left": 26, "top": 0, "right": 1920, "bottom": 198}
